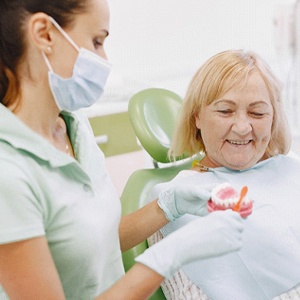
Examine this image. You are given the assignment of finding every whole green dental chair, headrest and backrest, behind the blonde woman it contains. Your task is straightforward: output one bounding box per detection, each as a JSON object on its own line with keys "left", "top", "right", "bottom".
{"left": 121, "top": 88, "right": 196, "bottom": 300}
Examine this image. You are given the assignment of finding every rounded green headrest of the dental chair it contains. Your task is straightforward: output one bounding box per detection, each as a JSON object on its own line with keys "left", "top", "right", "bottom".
{"left": 128, "top": 88, "right": 182, "bottom": 163}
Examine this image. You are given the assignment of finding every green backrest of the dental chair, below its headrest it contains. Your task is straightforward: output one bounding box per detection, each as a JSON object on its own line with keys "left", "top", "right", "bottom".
{"left": 121, "top": 160, "right": 192, "bottom": 300}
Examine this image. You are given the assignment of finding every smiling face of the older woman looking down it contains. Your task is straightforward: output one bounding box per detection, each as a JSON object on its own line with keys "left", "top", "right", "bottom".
{"left": 196, "top": 72, "right": 273, "bottom": 170}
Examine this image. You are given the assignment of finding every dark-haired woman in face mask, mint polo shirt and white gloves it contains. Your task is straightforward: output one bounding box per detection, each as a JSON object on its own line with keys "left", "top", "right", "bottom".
{"left": 0, "top": 0, "right": 243, "bottom": 300}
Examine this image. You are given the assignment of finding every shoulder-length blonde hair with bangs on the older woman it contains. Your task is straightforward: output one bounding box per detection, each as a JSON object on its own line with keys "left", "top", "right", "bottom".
{"left": 169, "top": 50, "right": 291, "bottom": 159}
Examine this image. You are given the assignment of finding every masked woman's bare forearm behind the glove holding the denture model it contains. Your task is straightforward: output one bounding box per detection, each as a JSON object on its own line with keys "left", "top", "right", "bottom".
{"left": 119, "top": 200, "right": 169, "bottom": 252}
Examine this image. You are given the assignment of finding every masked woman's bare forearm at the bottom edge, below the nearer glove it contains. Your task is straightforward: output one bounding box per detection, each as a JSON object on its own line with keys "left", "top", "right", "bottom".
{"left": 95, "top": 263, "right": 164, "bottom": 300}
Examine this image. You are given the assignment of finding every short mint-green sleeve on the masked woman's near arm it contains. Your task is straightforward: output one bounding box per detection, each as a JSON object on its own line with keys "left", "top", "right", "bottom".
{"left": 0, "top": 160, "right": 45, "bottom": 244}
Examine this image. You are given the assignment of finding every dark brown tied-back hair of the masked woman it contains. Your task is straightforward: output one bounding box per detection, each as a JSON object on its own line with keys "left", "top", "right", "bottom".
{"left": 0, "top": 0, "right": 89, "bottom": 106}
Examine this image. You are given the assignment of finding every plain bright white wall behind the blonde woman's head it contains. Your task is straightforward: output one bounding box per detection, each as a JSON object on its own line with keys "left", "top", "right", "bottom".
{"left": 106, "top": 0, "right": 295, "bottom": 95}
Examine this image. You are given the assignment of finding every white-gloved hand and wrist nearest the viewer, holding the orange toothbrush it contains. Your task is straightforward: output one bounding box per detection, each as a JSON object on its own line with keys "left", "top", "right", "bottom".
{"left": 136, "top": 209, "right": 244, "bottom": 278}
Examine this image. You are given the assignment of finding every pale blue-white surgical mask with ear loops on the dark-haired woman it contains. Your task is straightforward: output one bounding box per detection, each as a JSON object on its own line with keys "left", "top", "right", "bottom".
{"left": 42, "top": 17, "right": 111, "bottom": 111}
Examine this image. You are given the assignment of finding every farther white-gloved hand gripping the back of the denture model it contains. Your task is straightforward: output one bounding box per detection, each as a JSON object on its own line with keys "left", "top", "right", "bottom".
{"left": 157, "top": 184, "right": 214, "bottom": 221}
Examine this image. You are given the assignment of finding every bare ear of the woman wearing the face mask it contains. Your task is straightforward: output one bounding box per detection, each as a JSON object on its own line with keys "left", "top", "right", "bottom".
{"left": 28, "top": 12, "right": 55, "bottom": 53}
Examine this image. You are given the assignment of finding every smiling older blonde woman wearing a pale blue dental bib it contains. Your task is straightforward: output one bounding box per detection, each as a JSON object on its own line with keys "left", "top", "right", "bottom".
{"left": 150, "top": 50, "right": 300, "bottom": 300}
